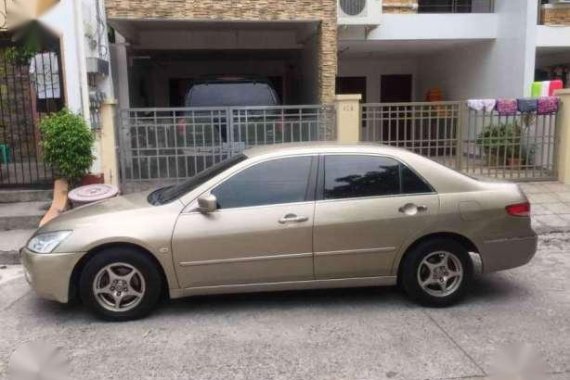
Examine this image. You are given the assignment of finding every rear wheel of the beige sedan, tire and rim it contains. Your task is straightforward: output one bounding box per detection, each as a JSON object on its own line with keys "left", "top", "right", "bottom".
{"left": 400, "top": 239, "right": 473, "bottom": 307}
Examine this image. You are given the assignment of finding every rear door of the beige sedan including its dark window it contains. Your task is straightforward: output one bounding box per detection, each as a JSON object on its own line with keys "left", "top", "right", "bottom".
{"left": 313, "top": 154, "right": 439, "bottom": 279}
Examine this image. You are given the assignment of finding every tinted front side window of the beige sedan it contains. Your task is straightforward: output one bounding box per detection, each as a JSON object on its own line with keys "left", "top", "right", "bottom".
{"left": 211, "top": 156, "right": 312, "bottom": 209}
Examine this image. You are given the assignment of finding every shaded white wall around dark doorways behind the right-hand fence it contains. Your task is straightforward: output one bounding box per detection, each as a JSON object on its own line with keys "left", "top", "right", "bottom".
{"left": 338, "top": 55, "right": 422, "bottom": 103}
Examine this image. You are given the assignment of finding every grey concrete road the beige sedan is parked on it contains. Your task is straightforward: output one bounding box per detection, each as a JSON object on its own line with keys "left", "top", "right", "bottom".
{"left": 0, "top": 234, "right": 570, "bottom": 380}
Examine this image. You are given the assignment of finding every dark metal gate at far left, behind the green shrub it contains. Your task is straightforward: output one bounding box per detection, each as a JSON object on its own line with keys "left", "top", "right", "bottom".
{"left": 0, "top": 34, "right": 64, "bottom": 188}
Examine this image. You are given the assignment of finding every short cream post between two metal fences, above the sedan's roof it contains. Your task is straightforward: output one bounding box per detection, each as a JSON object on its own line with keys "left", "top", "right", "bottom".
{"left": 336, "top": 94, "right": 362, "bottom": 144}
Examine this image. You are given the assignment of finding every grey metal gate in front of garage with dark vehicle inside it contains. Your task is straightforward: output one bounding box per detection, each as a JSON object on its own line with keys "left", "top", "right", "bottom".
{"left": 119, "top": 105, "right": 336, "bottom": 191}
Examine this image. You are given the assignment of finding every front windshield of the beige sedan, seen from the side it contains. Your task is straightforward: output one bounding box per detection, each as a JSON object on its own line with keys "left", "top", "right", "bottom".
{"left": 148, "top": 153, "right": 247, "bottom": 205}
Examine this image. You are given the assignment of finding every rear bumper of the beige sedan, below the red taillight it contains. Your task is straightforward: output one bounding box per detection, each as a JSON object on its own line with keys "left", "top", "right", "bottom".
{"left": 479, "top": 234, "right": 538, "bottom": 273}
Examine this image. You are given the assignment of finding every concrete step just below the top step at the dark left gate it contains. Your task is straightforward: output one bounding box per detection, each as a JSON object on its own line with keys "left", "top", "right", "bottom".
{"left": 0, "top": 202, "right": 50, "bottom": 231}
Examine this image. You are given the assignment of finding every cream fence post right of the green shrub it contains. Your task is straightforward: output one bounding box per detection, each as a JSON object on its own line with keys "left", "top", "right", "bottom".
{"left": 100, "top": 100, "right": 119, "bottom": 186}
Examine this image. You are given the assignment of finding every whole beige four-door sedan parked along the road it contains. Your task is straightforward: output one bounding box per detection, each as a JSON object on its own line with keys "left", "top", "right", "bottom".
{"left": 22, "top": 144, "right": 537, "bottom": 320}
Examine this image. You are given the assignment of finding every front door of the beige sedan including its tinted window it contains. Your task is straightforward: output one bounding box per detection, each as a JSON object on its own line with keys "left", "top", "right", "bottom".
{"left": 172, "top": 156, "right": 317, "bottom": 288}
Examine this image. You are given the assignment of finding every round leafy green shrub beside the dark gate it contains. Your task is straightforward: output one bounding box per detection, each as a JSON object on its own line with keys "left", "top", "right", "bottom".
{"left": 40, "top": 109, "right": 95, "bottom": 185}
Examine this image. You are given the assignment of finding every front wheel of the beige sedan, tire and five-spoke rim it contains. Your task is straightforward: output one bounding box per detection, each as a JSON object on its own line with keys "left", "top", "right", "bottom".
{"left": 79, "top": 247, "right": 162, "bottom": 321}
